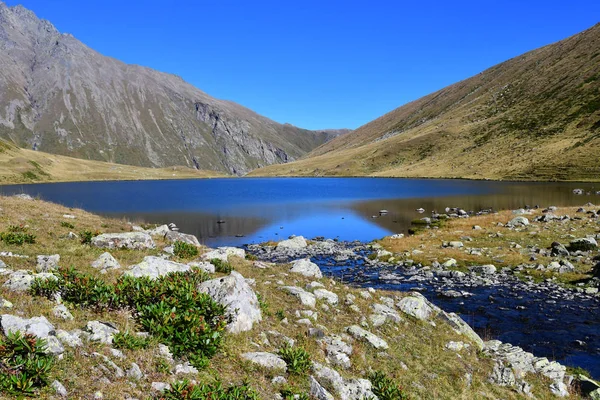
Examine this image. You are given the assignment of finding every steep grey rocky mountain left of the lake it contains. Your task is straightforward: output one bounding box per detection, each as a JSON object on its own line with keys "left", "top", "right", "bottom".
{"left": 0, "top": 1, "right": 346, "bottom": 174}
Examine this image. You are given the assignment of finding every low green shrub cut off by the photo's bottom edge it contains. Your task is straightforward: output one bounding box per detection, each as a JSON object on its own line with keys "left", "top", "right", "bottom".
{"left": 158, "top": 379, "right": 259, "bottom": 400}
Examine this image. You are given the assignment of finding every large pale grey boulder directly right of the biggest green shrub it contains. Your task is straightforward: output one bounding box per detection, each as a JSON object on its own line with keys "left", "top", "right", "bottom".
{"left": 198, "top": 271, "right": 262, "bottom": 333}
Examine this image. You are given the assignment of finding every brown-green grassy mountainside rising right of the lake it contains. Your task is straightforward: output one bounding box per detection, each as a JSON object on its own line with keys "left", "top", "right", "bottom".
{"left": 253, "top": 24, "right": 600, "bottom": 180}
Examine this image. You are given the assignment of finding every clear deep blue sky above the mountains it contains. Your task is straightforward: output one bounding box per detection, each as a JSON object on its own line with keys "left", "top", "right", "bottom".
{"left": 6, "top": 0, "right": 600, "bottom": 129}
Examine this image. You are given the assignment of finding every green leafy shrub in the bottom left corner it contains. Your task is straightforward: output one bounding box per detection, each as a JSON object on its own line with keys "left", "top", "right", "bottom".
{"left": 0, "top": 332, "right": 54, "bottom": 397}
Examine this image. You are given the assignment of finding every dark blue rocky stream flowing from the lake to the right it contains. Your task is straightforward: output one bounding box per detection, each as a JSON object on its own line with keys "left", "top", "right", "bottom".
{"left": 247, "top": 237, "right": 600, "bottom": 378}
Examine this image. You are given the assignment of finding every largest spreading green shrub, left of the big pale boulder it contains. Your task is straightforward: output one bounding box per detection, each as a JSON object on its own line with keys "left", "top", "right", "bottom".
{"left": 31, "top": 268, "right": 229, "bottom": 368}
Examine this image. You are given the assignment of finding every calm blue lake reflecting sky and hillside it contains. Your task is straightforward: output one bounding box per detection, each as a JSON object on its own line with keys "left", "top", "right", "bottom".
{"left": 0, "top": 178, "right": 600, "bottom": 247}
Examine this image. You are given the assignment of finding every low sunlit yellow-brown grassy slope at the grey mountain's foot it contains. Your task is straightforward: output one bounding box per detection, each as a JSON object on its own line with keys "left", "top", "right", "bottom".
{"left": 0, "top": 141, "right": 225, "bottom": 184}
